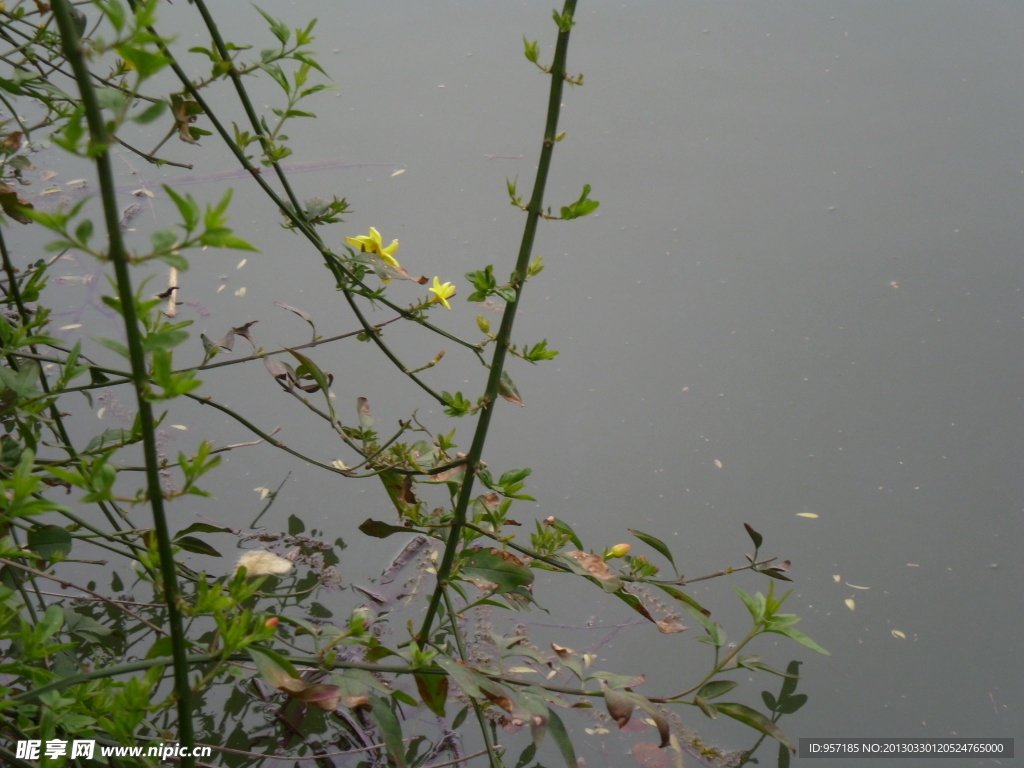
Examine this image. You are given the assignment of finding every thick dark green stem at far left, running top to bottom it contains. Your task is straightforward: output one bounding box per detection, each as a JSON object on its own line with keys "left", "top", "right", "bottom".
{"left": 52, "top": 0, "right": 196, "bottom": 768}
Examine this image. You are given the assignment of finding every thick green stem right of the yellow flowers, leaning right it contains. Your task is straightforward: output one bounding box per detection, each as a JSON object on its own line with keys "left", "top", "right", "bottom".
{"left": 417, "top": 0, "right": 575, "bottom": 645}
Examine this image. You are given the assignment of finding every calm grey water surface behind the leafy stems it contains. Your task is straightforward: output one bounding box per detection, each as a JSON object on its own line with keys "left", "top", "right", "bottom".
{"left": 12, "top": 0, "right": 1024, "bottom": 768}
